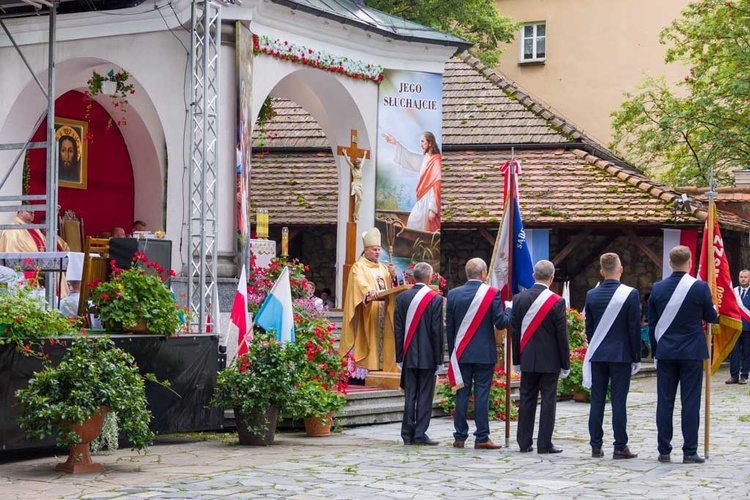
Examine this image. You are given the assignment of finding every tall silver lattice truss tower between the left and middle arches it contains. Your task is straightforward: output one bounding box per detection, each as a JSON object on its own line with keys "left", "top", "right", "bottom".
{"left": 188, "top": 0, "right": 221, "bottom": 332}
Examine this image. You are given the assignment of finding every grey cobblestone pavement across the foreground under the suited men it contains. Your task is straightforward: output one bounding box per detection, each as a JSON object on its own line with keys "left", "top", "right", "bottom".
{"left": 0, "top": 369, "right": 750, "bottom": 499}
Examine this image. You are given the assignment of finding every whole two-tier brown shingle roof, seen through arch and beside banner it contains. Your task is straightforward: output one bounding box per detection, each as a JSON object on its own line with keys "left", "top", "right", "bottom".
{"left": 251, "top": 55, "right": 750, "bottom": 231}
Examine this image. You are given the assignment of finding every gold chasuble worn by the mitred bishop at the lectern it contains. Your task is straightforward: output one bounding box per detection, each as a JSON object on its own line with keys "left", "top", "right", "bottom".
{"left": 339, "top": 257, "right": 393, "bottom": 370}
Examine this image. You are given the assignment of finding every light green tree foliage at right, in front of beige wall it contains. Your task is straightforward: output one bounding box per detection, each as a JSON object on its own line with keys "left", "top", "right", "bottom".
{"left": 612, "top": 0, "right": 750, "bottom": 186}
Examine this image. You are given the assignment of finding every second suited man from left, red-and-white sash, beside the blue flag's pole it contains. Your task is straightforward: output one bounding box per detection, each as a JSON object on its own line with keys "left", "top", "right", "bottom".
{"left": 446, "top": 258, "right": 511, "bottom": 450}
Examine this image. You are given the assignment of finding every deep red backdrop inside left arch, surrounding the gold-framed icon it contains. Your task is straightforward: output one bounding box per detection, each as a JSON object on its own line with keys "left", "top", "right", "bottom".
{"left": 29, "top": 90, "right": 134, "bottom": 236}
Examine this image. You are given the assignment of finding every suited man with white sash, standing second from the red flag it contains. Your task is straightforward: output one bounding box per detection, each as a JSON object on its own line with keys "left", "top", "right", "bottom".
{"left": 583, "top": 253, "right": 641, "bottom": 459}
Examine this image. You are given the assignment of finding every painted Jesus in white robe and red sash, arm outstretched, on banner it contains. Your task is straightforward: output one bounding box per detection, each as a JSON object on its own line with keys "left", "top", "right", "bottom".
{"left": 383, "top": 132, "right": 443, "bottom": 232}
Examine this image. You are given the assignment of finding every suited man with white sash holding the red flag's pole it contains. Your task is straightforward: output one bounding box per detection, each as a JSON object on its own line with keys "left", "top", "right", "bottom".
{"left": 648, "top": 245, "right": 717, "bottom": 464}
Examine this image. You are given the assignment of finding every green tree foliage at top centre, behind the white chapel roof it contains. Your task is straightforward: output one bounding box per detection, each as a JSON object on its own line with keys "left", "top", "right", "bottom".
{"left": 365, "top": 0, "right": 518, "bottom": 67}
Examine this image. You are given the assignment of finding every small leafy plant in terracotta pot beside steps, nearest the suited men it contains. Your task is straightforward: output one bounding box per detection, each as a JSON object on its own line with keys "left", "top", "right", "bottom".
{"left": 284, "top": 380, "right": 346, "bottom": 437}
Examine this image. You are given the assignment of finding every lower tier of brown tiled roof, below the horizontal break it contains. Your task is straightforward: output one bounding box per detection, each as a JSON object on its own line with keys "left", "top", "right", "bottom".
{"left": 251, "top": 148, "right": 750, "bottom": 230}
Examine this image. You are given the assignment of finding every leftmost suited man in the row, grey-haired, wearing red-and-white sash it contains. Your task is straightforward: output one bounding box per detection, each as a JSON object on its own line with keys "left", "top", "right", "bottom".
{"left": 393, "top": 262, "right": 443, "bottom": 445}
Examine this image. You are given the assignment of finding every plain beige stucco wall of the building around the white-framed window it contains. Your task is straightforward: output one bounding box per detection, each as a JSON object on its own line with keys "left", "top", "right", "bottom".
{"left": 497, "top": 0, "right": 689, "bottom": 145}
